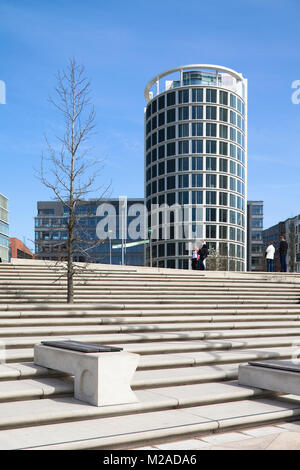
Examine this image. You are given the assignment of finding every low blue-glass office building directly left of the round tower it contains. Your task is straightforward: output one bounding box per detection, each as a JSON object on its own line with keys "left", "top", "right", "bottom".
{"left": 35, "top": 197, "right": 145, "bottom": 266}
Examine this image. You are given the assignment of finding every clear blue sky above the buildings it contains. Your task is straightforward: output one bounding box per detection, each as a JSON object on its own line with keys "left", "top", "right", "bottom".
{"left": 0, "top": 0, "right": 300, "bottom": 248}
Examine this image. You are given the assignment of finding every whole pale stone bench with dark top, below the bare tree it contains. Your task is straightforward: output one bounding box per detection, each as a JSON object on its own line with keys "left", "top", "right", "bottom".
{"left": 34, "top": 341, "right": 139, "bottom": 406}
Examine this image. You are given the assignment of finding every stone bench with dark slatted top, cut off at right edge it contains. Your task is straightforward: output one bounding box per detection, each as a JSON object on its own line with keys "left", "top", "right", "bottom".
{"left": 238, "top": 360, "right": 300, "bottom": 395}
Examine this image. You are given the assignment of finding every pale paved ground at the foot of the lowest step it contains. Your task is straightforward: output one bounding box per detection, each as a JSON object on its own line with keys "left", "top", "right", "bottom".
{"left": 135, "top": 421, "right": 300, "bottom": 451}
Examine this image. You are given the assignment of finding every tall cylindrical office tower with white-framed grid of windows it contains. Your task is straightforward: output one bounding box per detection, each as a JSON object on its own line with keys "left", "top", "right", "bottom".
{"left": 145, "top": 64, "right": 247, "bottom": 271}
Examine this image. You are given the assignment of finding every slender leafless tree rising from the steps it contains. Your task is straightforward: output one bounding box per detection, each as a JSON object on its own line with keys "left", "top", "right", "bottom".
{"left": 39, "top": 59, "right": 107, "bottom": 303}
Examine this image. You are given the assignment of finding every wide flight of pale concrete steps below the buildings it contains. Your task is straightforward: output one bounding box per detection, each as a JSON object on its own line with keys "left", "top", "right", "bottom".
{"left": 0, "top": 261, "right": 300, "bottom": 449}
